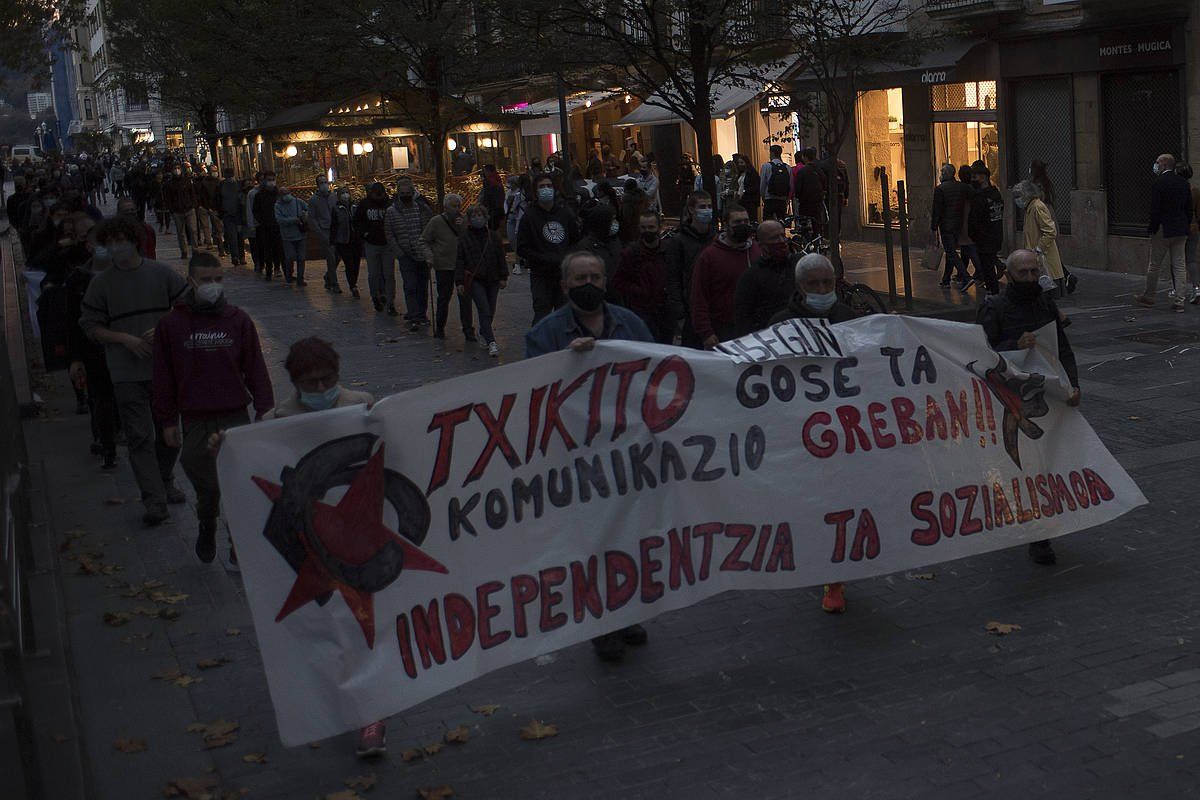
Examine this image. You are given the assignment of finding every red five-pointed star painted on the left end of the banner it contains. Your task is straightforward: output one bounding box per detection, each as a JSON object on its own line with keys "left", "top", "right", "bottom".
{"left": 253, "top": 446, "right": 446, "bottom": 648}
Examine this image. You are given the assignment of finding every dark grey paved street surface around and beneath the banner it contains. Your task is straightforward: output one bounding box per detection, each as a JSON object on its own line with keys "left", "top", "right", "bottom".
{"left": 18, "top": 211, "right": 1200, "bottom": 800}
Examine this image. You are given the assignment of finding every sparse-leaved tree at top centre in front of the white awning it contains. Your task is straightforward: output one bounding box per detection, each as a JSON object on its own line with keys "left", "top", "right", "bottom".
{"left": 503, "top": 0, "right": 787, "bottom": 195}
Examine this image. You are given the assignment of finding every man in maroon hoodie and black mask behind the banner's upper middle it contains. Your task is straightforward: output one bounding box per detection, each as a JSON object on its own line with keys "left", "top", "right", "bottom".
{"left": 691, "top": 203, "right": 762, "bottom": 350}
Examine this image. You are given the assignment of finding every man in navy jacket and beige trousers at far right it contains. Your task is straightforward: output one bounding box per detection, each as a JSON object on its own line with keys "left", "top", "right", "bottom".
{"left": 1133, "top": 152, "right": 1195, "bottom": 313}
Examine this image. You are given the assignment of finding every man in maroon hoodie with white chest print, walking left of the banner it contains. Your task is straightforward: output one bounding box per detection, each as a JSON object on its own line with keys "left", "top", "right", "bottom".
{"left": 154, "top": 252, "right": 275, "bottom": 564}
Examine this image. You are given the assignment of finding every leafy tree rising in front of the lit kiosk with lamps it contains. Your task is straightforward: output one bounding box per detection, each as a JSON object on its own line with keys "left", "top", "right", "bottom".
{"left": 311, "top": 0, "right": 502, "bottom": 206}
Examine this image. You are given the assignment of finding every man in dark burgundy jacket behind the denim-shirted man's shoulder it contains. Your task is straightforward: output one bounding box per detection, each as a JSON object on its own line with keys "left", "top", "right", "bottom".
{"left": 612, "top": 211, "right": 674, "bottom": 344}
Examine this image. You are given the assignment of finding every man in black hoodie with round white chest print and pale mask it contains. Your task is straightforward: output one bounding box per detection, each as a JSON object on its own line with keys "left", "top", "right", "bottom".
{"left": 517, "top": 175, "right": 580, "bottom": 325}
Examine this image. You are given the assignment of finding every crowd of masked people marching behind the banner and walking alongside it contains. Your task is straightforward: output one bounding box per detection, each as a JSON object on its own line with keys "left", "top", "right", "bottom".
{"left": 39, "top": 139, "right": 1200, "bottom": 756}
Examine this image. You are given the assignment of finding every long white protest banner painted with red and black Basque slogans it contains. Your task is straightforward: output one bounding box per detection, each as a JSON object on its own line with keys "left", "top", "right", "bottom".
{"left": 218, "top": 315, "right": 1145, "bottom": 745}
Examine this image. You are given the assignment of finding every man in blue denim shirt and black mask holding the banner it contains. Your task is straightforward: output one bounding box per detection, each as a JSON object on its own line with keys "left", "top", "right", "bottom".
{"left": 526, "top": 251, "right": 654, "bottom": 661}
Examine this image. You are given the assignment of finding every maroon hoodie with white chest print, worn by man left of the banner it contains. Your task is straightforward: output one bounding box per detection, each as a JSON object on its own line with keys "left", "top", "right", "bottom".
{"left": 152, "top": 303, "right": 275, "bottom": 425}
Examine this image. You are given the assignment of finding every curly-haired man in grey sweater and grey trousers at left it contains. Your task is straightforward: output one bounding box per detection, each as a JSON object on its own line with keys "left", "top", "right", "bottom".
{"left": 79, "top": 217, "right": 187, "bottom": 525}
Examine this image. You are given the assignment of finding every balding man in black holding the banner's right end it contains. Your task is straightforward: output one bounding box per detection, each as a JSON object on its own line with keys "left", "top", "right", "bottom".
{"left": 976, "top": 249, "right": 1080, "bottom": 564}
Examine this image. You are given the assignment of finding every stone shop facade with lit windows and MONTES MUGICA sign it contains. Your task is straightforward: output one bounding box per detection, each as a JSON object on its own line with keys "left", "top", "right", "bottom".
{"left": 806, "top": 0, "right": 1200, "bottom": 272}
